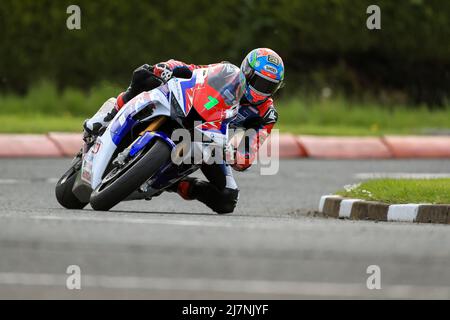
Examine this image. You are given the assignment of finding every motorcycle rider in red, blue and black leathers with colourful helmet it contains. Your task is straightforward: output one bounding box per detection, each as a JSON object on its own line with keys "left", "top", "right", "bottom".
{"left": 84, "top": 48, "right": 284, "bottom": 213}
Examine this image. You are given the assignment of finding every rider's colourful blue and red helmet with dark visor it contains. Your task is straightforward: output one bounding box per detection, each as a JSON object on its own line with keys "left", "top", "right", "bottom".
{"left": 241, "top": 48, "right": 284, "bottom": 104}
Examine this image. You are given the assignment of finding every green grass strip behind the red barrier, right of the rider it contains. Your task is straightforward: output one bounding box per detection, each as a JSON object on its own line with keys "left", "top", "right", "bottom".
{"left": 277, "top": 97, "right": 450, "bottom": 136}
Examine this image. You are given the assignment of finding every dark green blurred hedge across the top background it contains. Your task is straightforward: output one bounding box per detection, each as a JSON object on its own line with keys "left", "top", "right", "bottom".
{"left": 0, "top": 0, "right": 450, "bottom": 106}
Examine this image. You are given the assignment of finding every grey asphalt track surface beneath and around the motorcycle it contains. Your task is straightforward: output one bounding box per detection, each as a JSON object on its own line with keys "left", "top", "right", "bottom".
{"left": 0, "top": 159, "right": 450, "bottom": 299}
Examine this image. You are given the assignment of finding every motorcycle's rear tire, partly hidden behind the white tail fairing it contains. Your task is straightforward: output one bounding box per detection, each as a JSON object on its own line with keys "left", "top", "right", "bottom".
{"left": 55, "top": 158, "right": 87, "bottom": 210}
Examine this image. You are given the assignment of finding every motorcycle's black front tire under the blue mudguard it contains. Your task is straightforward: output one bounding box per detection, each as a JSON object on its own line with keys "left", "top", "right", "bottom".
{"left": 90, "top": 139, "right": 171, "bottom": 211}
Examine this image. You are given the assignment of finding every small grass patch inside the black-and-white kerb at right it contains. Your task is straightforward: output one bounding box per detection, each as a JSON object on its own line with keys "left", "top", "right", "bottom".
{"left": 337, "top": 178, "right": 450, "bottom": 204}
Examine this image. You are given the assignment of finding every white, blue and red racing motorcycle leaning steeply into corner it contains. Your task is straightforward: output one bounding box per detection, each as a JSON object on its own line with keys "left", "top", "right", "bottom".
{"left": 55, "top": 63, "right": 245, "bottom": 211}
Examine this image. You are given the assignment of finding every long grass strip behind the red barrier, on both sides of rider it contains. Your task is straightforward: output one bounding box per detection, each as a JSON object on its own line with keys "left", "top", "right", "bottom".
{"left": 0, "top": 82, "right": 450, "bottom": 136}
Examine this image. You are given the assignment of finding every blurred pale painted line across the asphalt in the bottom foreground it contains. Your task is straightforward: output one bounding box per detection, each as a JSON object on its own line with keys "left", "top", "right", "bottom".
{"left": 0, "top": 273, "right": 450, "bottom": 299}
